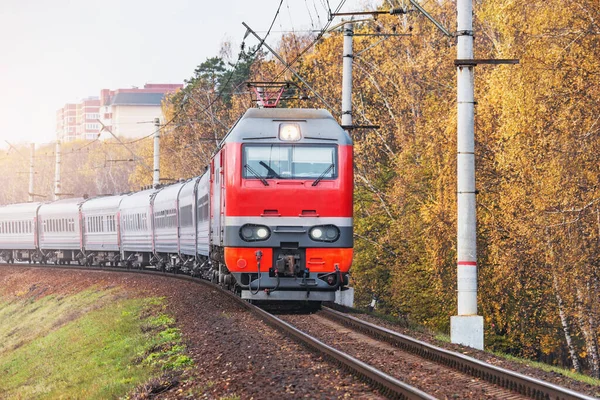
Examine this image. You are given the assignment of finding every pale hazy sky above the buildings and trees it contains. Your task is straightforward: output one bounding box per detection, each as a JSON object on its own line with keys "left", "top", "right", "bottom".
{"left": 0, "top": 0, "right": 381, "bottom": 145}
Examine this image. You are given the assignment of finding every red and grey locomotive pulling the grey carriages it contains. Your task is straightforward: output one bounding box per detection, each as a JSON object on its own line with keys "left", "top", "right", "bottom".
{"left": 210, "top": 108, "right": 353, "bottom": 302}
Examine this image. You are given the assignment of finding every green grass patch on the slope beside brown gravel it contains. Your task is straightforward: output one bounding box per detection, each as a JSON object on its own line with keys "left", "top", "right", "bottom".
{"left": 0, "top": 291, "right": 192, "bottom": 399}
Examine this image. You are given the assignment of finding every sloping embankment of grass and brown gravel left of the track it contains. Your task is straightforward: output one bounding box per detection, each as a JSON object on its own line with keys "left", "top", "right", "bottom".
{"left": 0, "top": 266, "right": 381, "bottom": 399}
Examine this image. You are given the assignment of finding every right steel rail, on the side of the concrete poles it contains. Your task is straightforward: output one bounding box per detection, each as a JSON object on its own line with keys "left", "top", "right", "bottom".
{"left": 322, "top": 307, "right": 595, "bottom": 400}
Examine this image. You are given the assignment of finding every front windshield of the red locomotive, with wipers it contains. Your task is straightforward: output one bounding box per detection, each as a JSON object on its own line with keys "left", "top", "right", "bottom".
{"left": 242, "top": 144, "right": 337, "bottom": 179}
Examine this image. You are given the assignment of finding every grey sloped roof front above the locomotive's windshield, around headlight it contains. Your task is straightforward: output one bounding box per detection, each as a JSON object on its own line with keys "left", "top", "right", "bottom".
{"left": 223, "top": 108, "right": 352, "bottom": 145}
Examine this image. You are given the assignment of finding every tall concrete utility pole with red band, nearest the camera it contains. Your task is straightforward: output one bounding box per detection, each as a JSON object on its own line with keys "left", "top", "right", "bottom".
{"left": 450, "top": 0, "right": 483, "bottom": 349}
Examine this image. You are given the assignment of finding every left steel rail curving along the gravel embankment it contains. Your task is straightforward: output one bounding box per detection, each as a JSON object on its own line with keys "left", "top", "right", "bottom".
{"left": 3, "top": 264, "right": 436, "bottom": 400}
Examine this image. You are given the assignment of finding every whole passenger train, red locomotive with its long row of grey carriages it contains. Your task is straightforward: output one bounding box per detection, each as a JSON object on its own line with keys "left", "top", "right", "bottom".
{"left": 0, "top": 108, "right": 353, "bottom": 304}
